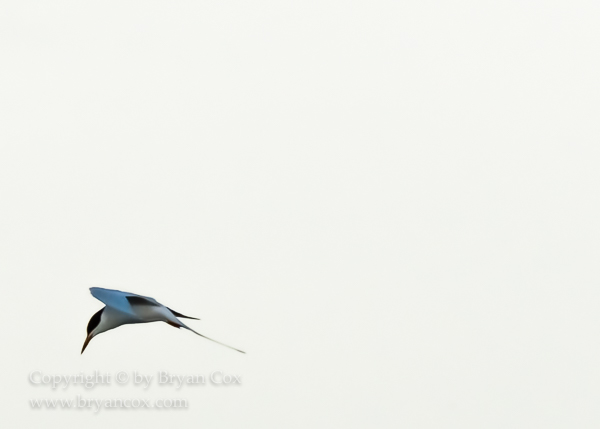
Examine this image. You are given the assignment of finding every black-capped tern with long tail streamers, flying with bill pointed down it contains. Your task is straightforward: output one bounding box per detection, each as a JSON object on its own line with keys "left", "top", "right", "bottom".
{"left": 81, "top": 287, "right": 245, "bottom": 353}
